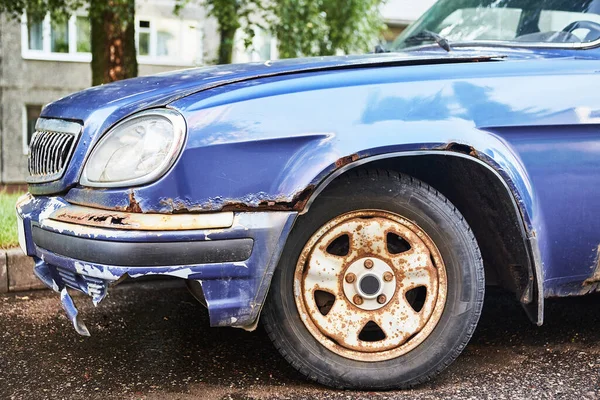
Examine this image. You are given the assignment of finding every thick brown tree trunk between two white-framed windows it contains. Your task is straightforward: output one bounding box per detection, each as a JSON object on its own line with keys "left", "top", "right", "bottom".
{"left": 90, "top": 0, "right": 138, "bottom": 86}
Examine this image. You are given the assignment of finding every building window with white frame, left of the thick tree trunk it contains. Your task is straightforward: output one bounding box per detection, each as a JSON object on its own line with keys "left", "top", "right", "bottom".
{"left": 21, "top": 15, "right": 92, "bottom": 62}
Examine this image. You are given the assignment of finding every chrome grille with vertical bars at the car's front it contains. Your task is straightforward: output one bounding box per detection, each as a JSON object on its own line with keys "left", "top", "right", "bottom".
{"left": 28, "top": 118, "right": 81, "bottom": 183}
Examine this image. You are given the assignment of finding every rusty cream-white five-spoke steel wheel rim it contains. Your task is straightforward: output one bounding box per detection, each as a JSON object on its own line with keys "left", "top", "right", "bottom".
{"left": 294, "top": 210, "right": 447, "bottom": 361}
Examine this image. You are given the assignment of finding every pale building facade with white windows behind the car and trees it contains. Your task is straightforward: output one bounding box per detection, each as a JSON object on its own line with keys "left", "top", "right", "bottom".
{"left": 0, "top": 0, "right": 433, "bottom": 184}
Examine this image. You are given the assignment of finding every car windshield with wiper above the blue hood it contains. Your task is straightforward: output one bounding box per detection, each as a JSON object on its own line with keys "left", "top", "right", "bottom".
{"left": 391, "top": 0, "right": 600, "bottom": 50}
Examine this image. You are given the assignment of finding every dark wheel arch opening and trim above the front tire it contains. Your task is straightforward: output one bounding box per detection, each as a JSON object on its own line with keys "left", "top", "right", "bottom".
{"left": 302, "top": 150, "right": 544, "bottom": 325}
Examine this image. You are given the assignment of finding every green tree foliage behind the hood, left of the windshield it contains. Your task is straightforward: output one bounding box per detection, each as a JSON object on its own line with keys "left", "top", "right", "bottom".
{"left": 175, "top": 0, "right": 385, "bottom": 62}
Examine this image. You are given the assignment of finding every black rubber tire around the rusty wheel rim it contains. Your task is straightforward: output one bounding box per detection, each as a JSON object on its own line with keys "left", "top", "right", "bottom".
{"left": 262, "top": 169, "right": 485, "bottom": 390}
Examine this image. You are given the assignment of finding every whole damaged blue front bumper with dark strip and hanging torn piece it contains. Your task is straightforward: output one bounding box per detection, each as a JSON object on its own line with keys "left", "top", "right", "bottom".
{"left": 17, "top": 194, "right": 296, "bottom": 335}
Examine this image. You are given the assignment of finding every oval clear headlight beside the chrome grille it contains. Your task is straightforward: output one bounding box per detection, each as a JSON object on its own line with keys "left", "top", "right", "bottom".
{"left": 81, "top": 109, "right": 186, "bottom": 187}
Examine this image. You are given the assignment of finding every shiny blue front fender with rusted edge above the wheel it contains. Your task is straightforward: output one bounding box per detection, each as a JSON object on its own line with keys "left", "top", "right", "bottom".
{"left": 162, "top": 59, "right": 600, "bottom": 296}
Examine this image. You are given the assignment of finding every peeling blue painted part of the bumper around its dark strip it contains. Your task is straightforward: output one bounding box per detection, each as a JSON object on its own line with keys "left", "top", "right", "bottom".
{"left": 19, "top": 197, "right": 296, "bottom": 327}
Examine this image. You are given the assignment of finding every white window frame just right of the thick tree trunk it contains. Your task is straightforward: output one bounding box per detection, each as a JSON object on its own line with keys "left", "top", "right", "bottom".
{"left": 135, "top": 15, "right": 204, "bottom": 67}
